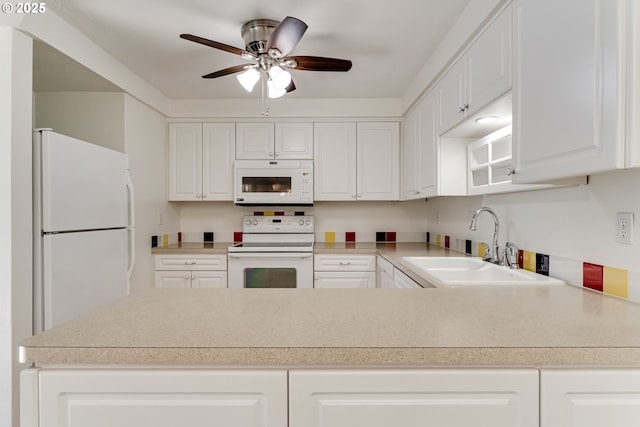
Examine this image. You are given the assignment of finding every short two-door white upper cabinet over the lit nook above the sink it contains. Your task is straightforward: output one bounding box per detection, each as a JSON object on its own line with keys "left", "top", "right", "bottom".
{"left": 436, "top": 6, "right": 512, "bottom": 135}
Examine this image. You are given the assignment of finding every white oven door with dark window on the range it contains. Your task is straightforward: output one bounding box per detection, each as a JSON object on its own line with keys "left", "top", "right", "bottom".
{"left": 227, "top": 252, "right": 313, "bottom": 288}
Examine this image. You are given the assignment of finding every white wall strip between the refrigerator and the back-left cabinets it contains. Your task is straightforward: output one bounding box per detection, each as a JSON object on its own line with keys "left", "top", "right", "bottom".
{"left": 124, "top": 95, "right": 180, "bottom": 292}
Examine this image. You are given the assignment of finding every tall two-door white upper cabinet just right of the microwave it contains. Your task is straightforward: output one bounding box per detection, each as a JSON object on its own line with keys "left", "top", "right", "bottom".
{"left": 314, "top": 122, "right": 400, "bottom": 201}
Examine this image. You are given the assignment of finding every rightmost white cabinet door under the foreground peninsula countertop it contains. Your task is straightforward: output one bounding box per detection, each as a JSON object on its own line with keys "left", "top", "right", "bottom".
{"left": 540, "top": 369, "right": 640, "bottom": 427}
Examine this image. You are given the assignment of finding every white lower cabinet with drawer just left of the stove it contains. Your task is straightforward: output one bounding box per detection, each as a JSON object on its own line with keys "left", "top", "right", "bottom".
{"left": 155, "top": 254, "right": 227, "bottom": 288}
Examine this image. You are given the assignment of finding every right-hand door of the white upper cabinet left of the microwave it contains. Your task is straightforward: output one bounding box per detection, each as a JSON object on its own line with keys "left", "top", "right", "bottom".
{"left": 202, "top": 123, "right": 236, "bottom": 200}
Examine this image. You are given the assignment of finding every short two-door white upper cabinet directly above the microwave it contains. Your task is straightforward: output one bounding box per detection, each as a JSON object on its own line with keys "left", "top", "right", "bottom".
{"left": 236, "top": 123, "right": 313, "bottom": 160}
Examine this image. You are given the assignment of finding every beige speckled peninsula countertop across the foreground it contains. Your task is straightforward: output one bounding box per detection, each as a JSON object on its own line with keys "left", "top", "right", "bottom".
{"left": 20, "top": 286, "right": 640, "bottom": 366}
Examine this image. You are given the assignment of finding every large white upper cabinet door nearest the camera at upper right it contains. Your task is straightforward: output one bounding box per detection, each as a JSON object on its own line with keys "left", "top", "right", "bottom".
{"left": 513, "top": 0, "right": 625, "bottom": 183}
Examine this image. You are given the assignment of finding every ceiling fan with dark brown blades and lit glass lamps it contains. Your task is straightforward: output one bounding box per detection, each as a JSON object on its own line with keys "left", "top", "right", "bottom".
{"left": 180, "top": 16, "right": 351, "bottom": 98}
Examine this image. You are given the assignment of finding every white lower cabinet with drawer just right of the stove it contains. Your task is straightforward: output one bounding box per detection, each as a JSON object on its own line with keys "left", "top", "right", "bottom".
{"left": 313, "top": 254, "right": 376, "bottom": 288}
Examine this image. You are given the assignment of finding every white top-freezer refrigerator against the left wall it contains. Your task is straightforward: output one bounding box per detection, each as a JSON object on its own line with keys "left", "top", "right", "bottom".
{"left": 33, "top": 129, "right": 134, "bottom": 333}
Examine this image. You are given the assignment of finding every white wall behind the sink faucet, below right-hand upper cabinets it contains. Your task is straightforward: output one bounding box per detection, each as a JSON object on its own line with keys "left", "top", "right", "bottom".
{"left": 427, "top": 169, "right": 640, "bottom": 274}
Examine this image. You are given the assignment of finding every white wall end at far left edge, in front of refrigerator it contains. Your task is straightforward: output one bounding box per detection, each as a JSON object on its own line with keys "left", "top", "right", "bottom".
{"left": 0, "top": 27, "right": 33, "bottom": 427}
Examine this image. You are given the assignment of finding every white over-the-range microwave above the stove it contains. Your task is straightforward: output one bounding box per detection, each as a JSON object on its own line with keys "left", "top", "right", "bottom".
{"left": 234, "top": 160, "right": 313, "bottom": 206}
